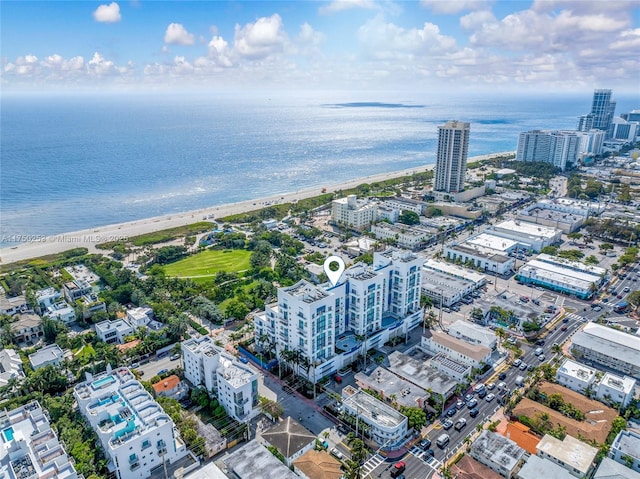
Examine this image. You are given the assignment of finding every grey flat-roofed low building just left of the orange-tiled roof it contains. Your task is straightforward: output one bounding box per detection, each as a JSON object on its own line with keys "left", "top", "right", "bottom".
{"left": 469, "top": 429, "right": 527, "bottom": 479}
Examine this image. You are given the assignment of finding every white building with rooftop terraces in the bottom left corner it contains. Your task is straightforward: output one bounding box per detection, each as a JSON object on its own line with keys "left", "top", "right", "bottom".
{"left": 0, "top": 401, "right": 82, "bottom": 479}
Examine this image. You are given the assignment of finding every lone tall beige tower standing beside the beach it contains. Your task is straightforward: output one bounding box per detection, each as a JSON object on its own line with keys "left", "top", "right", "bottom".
{"left": 434, "top": 121, "right": 470, "bottom": 193}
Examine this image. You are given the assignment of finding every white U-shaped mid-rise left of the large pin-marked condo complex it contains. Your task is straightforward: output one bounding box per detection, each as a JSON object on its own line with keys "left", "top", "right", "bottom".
{"left": 182, "top": 336, "right": 259, "bottom": 421}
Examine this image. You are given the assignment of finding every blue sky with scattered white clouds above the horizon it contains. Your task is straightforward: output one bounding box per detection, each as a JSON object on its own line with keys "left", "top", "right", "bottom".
{"left": 0, "top": 0, "right": 640, "bottom": 94}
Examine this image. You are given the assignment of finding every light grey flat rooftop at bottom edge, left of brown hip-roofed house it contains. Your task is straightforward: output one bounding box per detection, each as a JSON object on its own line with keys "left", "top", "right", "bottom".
{"left": 222, "top": 440, "right": 299, "bottom": 479}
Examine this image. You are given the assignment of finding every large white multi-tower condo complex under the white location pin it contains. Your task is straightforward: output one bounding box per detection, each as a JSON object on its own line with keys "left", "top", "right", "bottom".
{"left": 254, "top": 249, "right": 423, "bottom": 380}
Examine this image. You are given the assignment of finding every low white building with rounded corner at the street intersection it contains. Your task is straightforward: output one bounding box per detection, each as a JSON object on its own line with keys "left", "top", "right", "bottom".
{"left": 342, "top": 386, "right": 408, "bottom": 448}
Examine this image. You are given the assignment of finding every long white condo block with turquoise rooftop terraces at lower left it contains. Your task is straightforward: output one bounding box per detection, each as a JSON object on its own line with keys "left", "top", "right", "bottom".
{"left": 73, "top": 366, "right": 187, "bottom": 479}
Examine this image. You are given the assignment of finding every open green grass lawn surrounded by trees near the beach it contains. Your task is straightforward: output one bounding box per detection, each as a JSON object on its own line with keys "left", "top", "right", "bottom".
{"left": 164, "top": 249, "right": 251, "bottom": 278}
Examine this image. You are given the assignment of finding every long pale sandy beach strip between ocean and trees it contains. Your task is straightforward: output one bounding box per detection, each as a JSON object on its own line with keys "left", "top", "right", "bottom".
{"left": 0, "top": 152, "right": 513, "bottom": 265}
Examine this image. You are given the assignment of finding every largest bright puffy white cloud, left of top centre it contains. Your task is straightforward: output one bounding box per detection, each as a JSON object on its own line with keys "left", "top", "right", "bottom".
{"left": 234, "top": 13, "right": 288, "bottom": 60}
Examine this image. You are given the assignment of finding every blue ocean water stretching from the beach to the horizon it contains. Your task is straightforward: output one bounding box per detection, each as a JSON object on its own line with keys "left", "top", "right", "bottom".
{"left": 0, "top": 92, "right": 639, "bottom": 246}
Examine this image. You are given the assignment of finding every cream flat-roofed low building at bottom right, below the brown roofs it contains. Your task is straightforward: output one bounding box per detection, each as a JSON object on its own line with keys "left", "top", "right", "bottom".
{"left": 537, "top": 434, "right": 598, "bottom": 478}
